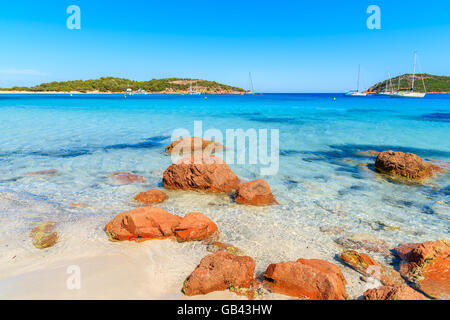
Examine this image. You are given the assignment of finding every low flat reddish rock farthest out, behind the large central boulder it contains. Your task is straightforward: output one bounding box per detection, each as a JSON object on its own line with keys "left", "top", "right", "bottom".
{"left": 166, "top": 137, "right": 225, "bottom": 155}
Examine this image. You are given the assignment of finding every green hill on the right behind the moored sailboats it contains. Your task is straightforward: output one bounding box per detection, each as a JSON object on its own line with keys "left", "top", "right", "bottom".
{"left": 368, "top": 73, "right": 450, "bottom": 93}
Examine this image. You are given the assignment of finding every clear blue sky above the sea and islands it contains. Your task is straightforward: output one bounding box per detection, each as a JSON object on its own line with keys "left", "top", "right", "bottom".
{"left": 0, "top": 0, "right": 450, "bottom": 92}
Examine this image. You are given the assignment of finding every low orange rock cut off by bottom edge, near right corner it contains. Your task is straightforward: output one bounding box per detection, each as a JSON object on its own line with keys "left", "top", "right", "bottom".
{"left": 363, "top": 284, "right": 428, "bottom": 300}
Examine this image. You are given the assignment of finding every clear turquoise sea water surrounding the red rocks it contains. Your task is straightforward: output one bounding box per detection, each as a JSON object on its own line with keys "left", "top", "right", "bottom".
{"left": 0, "top": 94, "right": 450, "bottom": 298}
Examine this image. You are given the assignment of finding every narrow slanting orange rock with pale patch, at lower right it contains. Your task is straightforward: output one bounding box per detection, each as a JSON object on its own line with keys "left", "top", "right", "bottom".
{"left": 339, "top": 250, "right": 405, "bottom": 285}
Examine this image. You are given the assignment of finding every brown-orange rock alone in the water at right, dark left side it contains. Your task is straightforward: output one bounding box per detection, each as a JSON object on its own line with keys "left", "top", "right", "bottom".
{"left": 375, "top": 151, "right": 440, "bottom": 181}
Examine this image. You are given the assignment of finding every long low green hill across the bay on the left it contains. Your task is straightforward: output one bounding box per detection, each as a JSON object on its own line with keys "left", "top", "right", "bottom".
{"left": 0, "top": 77, "right": 244, "bottom": 93}
